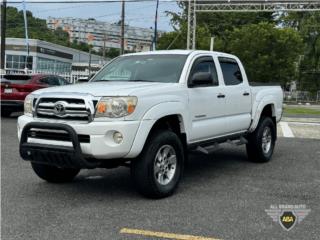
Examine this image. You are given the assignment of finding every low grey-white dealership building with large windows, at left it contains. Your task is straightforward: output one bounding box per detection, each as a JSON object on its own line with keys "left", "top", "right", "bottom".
{"left": 5, "top": 38, "right": 106, "bottom": 74}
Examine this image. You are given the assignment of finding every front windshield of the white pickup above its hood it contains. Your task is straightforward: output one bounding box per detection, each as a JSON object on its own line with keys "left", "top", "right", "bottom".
{"left": 91, "top": 54, "right": 187, "bottom": 83}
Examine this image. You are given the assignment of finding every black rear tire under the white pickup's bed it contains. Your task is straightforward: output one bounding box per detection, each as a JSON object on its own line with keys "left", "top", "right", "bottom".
{"left": 247, "top": 117, "right": 277, "bottom": 163}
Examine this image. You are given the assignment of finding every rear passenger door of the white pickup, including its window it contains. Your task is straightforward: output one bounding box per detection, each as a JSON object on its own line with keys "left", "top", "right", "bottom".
{"left": 218, "top": 57, "right": 252, "bottom": 133}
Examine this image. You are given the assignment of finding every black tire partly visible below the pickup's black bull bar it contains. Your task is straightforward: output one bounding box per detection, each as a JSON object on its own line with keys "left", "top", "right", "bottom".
{"left": 31, "top": 162, "right": 80, "bottom": 183}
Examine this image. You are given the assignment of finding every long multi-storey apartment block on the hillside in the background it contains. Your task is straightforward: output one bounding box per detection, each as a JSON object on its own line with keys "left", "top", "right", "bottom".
{"left": 47, "top": 17, "right": 162, "bottom": 52}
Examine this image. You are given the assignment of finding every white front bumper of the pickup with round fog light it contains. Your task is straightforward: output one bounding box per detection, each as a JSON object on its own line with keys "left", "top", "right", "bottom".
{"left": 17, "top": 115, "right": 140, "bottom": 165}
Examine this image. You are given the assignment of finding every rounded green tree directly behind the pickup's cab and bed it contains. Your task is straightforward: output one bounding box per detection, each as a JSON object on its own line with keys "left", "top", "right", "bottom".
{"left": 215, "top": 23, "right": 303, "bottom": 86}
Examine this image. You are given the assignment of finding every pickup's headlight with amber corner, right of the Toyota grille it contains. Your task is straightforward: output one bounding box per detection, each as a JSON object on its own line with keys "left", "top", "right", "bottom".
{"left": 95, "top": 97, "right": 138, "bottom": 118}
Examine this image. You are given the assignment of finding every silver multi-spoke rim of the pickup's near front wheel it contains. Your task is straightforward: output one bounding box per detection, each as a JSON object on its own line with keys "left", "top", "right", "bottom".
{"left": 154, "top": 145, "right": 177, "bottom": 185}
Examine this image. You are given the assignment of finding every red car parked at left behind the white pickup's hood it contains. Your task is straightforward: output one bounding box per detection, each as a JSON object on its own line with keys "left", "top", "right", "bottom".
{"left": 0, "top": 74, "right": 69, "bottom": 117}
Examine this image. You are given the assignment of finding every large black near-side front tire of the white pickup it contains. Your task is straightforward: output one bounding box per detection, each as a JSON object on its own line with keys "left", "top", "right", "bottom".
{"left": 131, "top": 130, "right": 184, "bottom": 198}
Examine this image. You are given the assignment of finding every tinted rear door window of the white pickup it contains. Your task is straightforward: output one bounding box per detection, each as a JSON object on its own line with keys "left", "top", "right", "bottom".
{"left": 219, "top": 57, "right": 243, "bottom": 86}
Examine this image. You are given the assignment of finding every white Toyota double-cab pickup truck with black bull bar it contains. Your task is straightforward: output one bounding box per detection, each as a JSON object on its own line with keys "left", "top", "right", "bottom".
{"left": 18, "top": 50, "right": 283, "bottom": 198}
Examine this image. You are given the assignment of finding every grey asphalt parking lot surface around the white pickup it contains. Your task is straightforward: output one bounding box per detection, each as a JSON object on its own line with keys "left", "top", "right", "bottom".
{"left": 1, "top": 117, "right": 320, "bottom": 240}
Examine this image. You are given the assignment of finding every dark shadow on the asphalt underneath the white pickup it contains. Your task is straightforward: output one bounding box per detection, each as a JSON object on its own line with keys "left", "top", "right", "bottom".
{"left": 34, "top": 144, "right": 255, "bottom": 200}
